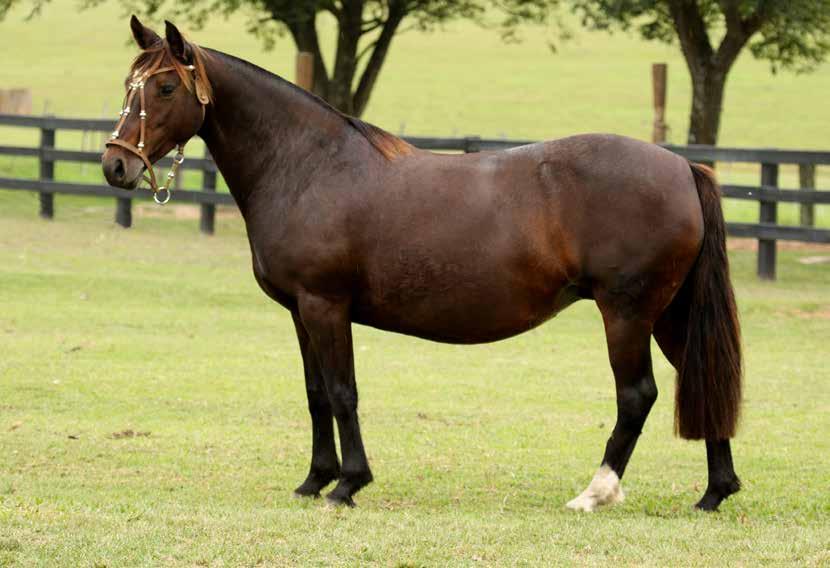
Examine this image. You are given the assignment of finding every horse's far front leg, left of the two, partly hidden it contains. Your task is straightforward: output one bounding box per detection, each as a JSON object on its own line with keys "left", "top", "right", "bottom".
{"left": 291, "top": 311, "right": 340, "bottom": 497}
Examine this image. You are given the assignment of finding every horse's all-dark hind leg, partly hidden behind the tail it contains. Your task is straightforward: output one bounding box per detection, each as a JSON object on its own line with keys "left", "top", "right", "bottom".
{"left": 654, "top": 287, "right": 741, "bottom": 511}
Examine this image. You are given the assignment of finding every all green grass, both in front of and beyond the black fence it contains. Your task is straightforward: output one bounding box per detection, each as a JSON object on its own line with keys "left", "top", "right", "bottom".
{"left": 0, "top": 0, "right": 830, "bottom": 566}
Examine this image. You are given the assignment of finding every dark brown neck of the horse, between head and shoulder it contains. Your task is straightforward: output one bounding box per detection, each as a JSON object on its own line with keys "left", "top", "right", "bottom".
{"left": 199, "top": 51, "right": 354, "bottom": 215}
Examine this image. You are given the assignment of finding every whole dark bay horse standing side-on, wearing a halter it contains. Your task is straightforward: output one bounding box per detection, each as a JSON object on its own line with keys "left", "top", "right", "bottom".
{"left": 102, "top": 17, "right": 741, "bottom": 511}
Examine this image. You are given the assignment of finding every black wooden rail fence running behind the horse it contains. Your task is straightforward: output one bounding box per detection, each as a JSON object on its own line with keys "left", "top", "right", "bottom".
{"left": 0, "top": 114, "right": 830, "bottom": 279}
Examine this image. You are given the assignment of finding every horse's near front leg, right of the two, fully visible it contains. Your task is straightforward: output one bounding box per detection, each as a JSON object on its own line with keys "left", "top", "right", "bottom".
{"left": 299, "top": 295, "right": 372, "bottom": 507}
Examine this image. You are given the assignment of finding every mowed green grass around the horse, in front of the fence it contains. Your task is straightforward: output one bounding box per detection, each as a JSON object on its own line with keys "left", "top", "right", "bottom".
{"left": 0, "top": 194, "right": 830, "bottom": 566}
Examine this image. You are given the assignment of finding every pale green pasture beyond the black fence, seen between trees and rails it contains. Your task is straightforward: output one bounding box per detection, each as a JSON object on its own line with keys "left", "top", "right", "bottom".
{"left": 0, "top": 0, "right": 830, "bottom": 227}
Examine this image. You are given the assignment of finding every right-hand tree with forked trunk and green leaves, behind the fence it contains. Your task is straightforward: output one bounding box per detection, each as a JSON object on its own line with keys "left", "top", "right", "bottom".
{"left": 568, "top": 0, "right": 830, "bottom": 144}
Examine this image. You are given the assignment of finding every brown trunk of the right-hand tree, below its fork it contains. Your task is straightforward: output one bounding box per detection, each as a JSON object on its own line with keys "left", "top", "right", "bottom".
{"left": 688, "top": 66, "right": 728, "bottom": 146}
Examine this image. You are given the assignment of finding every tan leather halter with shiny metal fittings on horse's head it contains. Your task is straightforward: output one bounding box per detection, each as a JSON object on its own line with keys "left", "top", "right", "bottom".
{"left": 106, "top": 55, "right": 209, "bottom": 205}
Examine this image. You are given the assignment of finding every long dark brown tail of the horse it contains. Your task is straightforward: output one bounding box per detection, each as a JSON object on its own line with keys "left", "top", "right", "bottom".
{"left": 675, "top": 162, "right": 741, "bottom": 440}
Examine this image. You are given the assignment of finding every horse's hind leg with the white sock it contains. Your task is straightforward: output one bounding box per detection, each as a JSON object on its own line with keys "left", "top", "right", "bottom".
{"left": 567, "top": 306, "right": 657, "bottom": 512}
